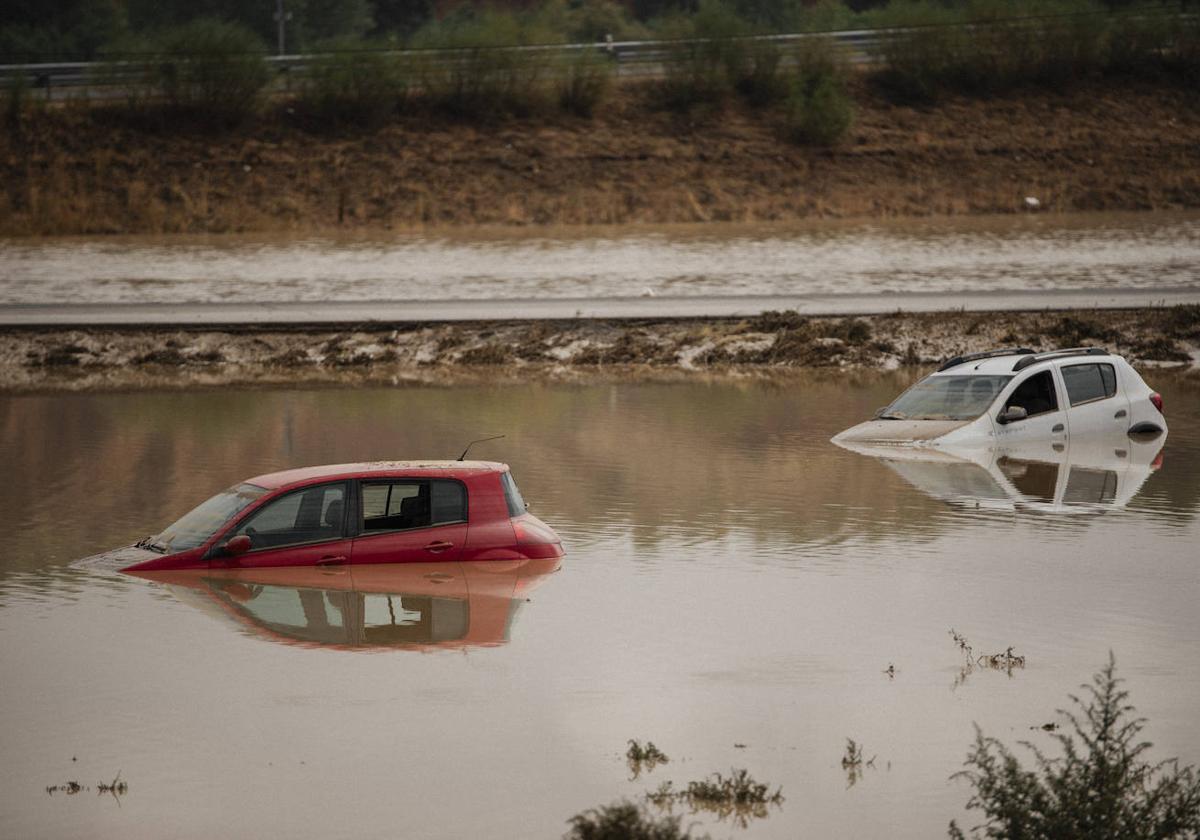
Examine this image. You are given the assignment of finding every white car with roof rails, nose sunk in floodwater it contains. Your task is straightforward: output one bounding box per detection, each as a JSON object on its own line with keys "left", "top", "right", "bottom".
{"left": 833, "top": 347, "right": 1166, "bottom": 449}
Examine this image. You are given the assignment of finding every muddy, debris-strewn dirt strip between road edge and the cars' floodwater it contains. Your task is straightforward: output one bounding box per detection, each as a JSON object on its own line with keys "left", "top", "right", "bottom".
{"left": 0, "top": 306, "right": 1200, "bottom": 391}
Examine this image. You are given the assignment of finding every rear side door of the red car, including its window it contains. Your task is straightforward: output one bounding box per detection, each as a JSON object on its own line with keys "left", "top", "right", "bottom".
{"left": 352, "top": 478, "right": 467, "bottom": 565}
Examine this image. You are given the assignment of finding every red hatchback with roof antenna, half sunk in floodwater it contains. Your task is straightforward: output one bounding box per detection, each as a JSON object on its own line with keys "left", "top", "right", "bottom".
{"left": 110, "top": 461, "right": 563, "bottom": 571}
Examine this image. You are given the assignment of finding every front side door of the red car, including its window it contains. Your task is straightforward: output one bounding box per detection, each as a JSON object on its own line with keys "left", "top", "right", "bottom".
{"left": 220, "top": 481, "right": 352, "bottom": 569}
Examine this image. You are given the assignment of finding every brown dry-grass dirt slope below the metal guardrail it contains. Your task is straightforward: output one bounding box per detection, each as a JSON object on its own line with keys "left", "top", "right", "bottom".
{"left": 0, "top": 82, "right": 1200, "bottom": 235}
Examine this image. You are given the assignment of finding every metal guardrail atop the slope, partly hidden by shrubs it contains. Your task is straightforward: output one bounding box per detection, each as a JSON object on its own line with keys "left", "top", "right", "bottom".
{"left": 0, "top": 6, "right": 1180, "bottom": 97}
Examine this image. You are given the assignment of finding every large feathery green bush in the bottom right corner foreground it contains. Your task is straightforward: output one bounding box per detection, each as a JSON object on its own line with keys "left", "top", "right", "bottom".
{"left": 950, "top": 654, "right": 1200, "bottom": 840}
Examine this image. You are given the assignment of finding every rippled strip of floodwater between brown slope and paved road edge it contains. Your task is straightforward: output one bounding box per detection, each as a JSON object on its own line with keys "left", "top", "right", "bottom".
{"left": 0, "top": 212, "right": 1200, "bottom": 305}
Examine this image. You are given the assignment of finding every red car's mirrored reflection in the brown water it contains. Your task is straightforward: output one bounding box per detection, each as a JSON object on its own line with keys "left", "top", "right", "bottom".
{"left": 134, "top": 558, "right": 560, "bottom": 650}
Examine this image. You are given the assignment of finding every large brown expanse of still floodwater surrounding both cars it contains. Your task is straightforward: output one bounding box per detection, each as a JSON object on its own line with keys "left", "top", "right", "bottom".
{"left": 0, "top": 373, "right": 1200, "bottom": 840}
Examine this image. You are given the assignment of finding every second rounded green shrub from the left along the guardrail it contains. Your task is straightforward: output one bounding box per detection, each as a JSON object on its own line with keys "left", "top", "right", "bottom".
{"left": 296, "top": 42, "right": 410, "bottom": 127}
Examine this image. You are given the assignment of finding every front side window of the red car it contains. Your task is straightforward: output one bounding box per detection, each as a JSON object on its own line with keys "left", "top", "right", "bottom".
{"left": 230, "top": 484, "right": 346, "bottom": 551}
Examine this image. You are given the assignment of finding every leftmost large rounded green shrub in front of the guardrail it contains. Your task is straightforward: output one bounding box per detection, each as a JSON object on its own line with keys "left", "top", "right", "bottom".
{"left": 152, "top": 18, "right": 270, "bottom": 124}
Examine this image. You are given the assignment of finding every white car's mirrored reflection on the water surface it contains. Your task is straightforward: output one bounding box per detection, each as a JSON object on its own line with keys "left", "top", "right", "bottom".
{"left": 846, "top": 433, "right": 1166, "bottom": 514}
